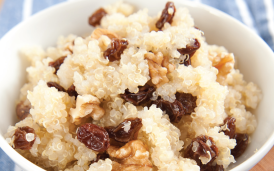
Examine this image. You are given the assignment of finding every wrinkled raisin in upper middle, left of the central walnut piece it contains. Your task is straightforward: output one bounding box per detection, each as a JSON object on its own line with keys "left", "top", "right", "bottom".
{"left": 104, "top": 38, "right": 128, "bottom": 62}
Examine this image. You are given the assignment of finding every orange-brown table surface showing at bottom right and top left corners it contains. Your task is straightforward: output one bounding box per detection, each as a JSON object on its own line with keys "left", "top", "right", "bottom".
{"left": 0, "top": 0, "right": 274, "bottom": 171}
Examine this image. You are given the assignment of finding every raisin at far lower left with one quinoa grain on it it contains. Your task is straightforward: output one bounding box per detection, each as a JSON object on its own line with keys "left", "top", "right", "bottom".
{"left": 13, "top": 126, "right": 36, "bottom": 150}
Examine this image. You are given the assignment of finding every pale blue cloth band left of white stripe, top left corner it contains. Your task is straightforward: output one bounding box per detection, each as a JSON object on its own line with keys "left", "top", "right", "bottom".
{"left": 0, "top": 0, "right": 24, "bottom": 38}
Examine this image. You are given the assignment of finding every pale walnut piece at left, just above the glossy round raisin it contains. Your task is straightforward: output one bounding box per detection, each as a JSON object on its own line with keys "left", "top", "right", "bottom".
{"left": 70, "top": 95, "right": 105, "bottom": 125}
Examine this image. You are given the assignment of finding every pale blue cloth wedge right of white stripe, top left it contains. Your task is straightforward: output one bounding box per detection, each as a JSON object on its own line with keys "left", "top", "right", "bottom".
{"left": 32, "top": 0, "right": 66, "bottom": 14}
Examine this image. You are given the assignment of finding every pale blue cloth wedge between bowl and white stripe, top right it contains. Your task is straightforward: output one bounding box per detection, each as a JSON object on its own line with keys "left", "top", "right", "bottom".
{"left": 201, "top": 0, "right": 243, "bottom": 22}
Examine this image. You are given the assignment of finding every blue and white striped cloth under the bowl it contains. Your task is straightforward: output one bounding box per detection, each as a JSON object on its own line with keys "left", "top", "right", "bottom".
{"left": 0, "top": 0, "right": 274, "bottom": 171}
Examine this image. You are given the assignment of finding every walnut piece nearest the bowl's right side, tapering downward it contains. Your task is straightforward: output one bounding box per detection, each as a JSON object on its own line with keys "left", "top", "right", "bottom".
{"left": 209, "top": 52, "right": 235, "bottom": 85}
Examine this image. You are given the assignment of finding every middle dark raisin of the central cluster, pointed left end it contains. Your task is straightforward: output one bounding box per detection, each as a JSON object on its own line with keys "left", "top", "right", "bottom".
{"left": 152, "top": 99, "right": 184, "bottom": 123}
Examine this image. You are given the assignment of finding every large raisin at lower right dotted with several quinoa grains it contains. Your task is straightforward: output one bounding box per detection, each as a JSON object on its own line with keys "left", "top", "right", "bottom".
{"left": 184, "top": 135, "right": 219, "bottom": 170}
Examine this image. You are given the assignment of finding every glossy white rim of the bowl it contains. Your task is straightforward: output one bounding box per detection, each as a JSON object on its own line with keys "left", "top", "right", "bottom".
{"left": 0, "top": 0, "right": 274, "bottom": 171}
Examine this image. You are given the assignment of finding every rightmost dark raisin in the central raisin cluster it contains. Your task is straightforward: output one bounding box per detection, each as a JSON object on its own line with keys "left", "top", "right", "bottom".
{"left": 176, "top": 92, "right": 197, "bottom": 115}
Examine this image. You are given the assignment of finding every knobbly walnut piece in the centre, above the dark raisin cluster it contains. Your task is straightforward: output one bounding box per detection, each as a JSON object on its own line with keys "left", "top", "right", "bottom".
{"left": 145, "top": 52, "right": 175, "bottom": 87}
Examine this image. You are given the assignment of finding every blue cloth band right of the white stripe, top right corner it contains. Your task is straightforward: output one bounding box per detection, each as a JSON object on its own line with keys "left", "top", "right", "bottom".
{"left": 246, "top": 0, "right": 274, "bottom": 50}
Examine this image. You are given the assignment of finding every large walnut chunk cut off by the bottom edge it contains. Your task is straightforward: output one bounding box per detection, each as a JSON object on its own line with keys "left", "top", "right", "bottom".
{"left": 107, "top": 140, "right": 152, "bottom": 171}
